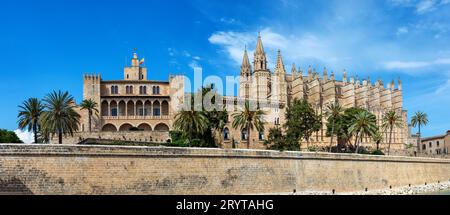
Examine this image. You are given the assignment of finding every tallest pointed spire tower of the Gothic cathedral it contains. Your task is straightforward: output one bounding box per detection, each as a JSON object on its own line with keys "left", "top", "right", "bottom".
{"left": 252, "top": 34, "right": 271, "bottom": 101}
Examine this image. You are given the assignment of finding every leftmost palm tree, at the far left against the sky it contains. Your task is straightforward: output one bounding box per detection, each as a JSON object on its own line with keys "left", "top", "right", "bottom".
{"left": 17, "top": 98, "right": 44, "bottom": 143}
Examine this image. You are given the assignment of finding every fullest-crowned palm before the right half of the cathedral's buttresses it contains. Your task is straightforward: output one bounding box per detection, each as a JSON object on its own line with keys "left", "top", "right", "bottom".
{"left": 349, "top": 111, "right": 378, "bottom": 153}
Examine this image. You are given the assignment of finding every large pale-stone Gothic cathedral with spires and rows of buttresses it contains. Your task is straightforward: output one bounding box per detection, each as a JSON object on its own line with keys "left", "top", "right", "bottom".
{"left": 222, "top": 35, "right": 409, "bottom": 150}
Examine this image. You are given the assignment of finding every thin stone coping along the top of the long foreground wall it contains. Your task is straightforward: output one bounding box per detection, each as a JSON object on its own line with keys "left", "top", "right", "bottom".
{"left": 0, "top": 144, "right": 450, "bottom": 164}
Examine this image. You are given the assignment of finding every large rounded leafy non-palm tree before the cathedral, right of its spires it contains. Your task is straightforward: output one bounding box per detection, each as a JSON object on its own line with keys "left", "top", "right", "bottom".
{"left": 283, "top": 99, "right": 322, "bottom": 148}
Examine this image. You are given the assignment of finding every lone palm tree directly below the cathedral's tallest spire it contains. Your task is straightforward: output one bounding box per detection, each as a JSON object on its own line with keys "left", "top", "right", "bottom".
{"left": 232, "top": 101, "right": 265, "bottom": 148}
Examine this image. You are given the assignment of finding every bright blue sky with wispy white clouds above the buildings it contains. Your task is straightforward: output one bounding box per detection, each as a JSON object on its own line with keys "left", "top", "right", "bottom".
{"left": 0, "top": 0, "right": 450, "bottom": 139}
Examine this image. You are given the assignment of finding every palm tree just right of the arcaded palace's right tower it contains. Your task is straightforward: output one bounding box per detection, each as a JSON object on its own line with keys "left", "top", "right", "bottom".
{"left": 173, "top": 109, "right": 208, "bottom": 146}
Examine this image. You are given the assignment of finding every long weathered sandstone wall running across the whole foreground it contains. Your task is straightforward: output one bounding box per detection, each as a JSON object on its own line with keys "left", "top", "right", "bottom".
{"left": 0, "top": 144, "right": 450, "bottom": 194}
